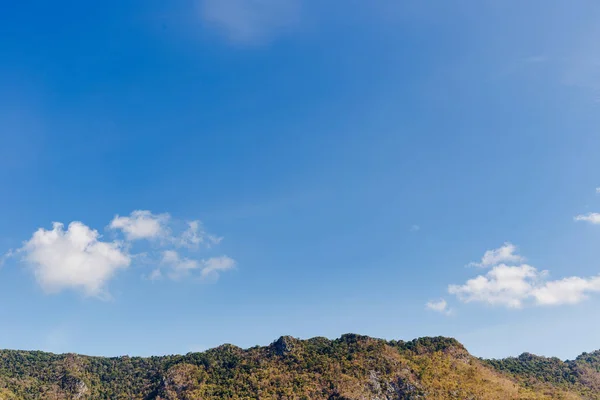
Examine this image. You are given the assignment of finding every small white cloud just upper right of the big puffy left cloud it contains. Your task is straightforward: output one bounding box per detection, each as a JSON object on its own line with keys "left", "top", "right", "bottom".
{"left": 109, "top": 210, "right": 171, "bottom": 240}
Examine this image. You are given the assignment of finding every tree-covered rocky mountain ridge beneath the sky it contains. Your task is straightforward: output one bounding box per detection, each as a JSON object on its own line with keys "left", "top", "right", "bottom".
{"left": 0, "top": 334, "right": 600, "bottom": 400}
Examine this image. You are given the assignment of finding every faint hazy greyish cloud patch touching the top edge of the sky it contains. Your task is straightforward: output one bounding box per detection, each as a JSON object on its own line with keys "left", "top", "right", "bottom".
{"left": 201, "top": 0, "right": 301, "bottom": 44}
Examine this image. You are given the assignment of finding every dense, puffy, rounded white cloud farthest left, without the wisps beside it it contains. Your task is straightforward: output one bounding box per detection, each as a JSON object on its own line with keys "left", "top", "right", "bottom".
{"left": 17, "top": 222, "right": 131, "bottom": 297}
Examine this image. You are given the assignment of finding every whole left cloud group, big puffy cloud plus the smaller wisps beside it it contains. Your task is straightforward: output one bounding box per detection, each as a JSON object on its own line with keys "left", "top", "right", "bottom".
{"left": 7, "top": 211, "right": 235, "bottom": 297}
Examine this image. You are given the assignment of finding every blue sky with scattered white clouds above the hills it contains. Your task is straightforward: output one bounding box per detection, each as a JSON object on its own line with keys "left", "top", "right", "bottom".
{"left": 0, "top": 0, "right": 600, "bottom": 358}
